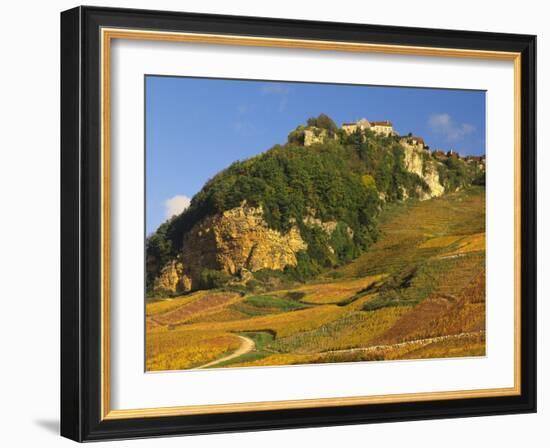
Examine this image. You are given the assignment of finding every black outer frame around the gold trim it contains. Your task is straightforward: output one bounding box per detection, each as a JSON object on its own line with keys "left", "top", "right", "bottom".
{"left": 61, "top": 7, "right": 536, "bottom": 441}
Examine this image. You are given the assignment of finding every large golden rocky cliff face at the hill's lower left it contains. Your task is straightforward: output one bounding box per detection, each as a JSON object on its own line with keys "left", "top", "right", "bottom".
{"left": 155, "top": 202, "right": 307, "bottom": 293}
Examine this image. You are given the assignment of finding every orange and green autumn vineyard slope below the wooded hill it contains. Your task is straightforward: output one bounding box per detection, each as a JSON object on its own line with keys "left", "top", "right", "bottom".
{"left": 146, "top": 187, "right": 485, "bottom": 370}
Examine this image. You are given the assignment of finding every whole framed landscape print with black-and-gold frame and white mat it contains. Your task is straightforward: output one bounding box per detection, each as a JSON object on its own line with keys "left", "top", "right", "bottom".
{"left": 61, "top": 7, "right": 536, "bottom": 441}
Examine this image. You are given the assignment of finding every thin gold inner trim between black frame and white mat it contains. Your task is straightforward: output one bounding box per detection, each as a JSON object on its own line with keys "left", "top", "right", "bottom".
{"left": 100, "top": 28, "right": 521, "bottom": 420}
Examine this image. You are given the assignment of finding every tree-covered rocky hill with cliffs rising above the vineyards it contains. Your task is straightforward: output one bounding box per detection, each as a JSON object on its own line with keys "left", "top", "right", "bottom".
{"left": 146, "top": 114, "right": 484, "bottom": 296}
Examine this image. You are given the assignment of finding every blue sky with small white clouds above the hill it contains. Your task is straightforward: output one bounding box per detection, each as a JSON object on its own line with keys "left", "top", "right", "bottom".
{"left": 145, "top": 76, "right": 485, "bottom": 234}
